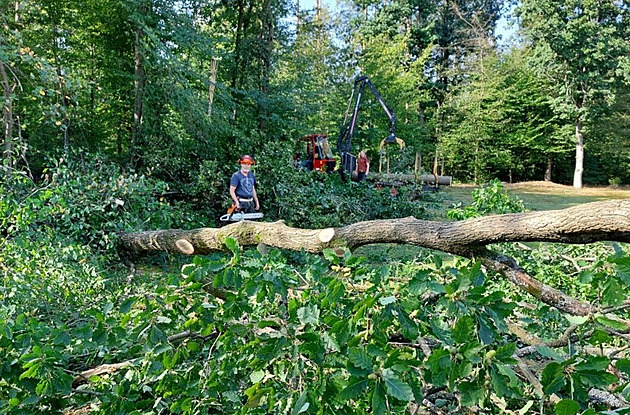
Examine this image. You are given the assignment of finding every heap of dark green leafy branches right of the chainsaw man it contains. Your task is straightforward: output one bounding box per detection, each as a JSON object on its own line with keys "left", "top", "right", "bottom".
{"left": 255, "top": 145, "right": 439, "bottom": 228}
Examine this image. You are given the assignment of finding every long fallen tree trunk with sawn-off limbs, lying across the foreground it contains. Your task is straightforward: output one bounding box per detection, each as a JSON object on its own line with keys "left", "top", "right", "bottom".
{"left": 121, "top": 200, "right": 630, "bottom": 315}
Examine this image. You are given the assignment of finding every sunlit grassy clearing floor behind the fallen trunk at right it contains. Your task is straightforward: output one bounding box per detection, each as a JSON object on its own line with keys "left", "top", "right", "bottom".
{"left": 442, "top": 181, "right": 630, "bottom": 210}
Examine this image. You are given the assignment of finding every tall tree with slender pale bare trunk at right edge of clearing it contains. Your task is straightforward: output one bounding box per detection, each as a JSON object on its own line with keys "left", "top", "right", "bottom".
{"left": 517, "top": 0, "right": 630, "bottom": 188}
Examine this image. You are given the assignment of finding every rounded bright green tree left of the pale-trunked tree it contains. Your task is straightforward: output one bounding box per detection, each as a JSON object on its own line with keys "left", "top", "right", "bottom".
{"left": 441, "top": 48, "right": 567, "bottom": 182}
